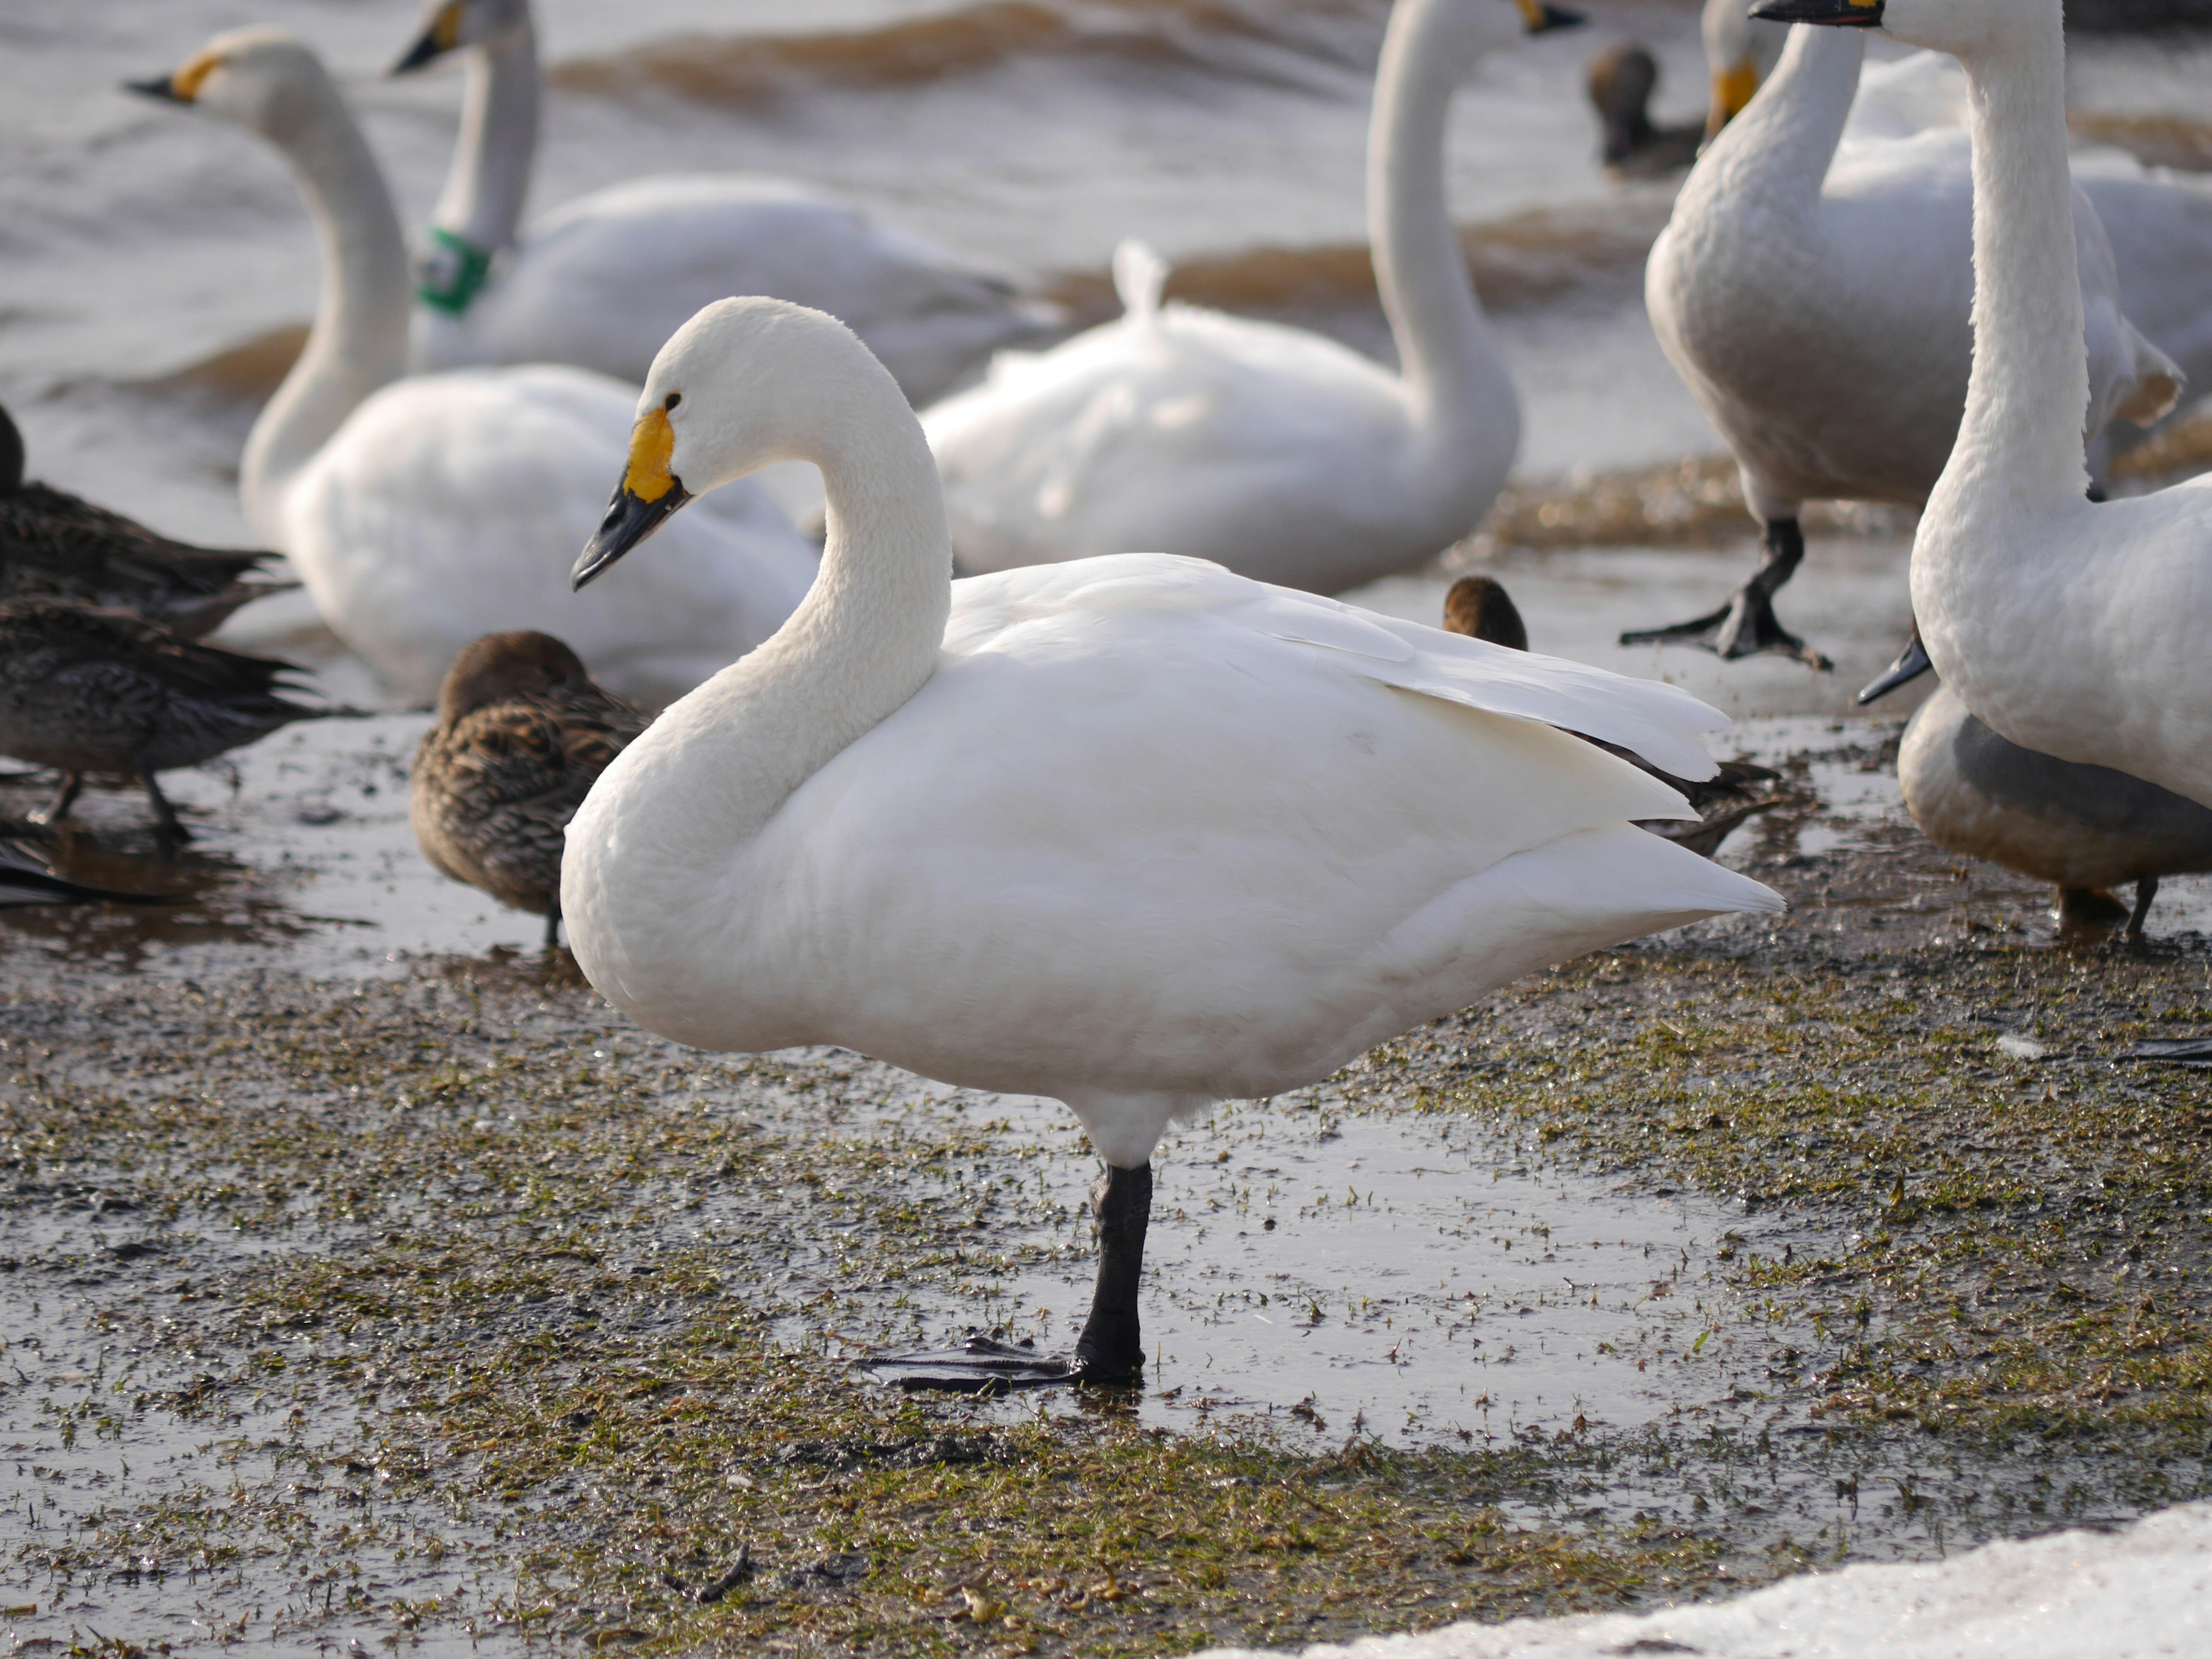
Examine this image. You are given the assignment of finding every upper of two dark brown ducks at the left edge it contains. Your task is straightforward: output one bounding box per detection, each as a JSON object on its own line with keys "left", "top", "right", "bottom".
{"left": 0, "top": 409, "right": 298, "bottom": 639}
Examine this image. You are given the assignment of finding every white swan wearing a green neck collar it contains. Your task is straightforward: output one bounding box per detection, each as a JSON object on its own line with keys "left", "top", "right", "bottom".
{"left": 394, "top": 0, "right": 1055, "bottom": 403}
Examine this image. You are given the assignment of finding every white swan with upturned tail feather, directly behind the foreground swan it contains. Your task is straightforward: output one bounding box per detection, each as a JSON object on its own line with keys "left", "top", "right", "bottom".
{"left": 922, "top": 0, "right": 1564, "bottom": 593}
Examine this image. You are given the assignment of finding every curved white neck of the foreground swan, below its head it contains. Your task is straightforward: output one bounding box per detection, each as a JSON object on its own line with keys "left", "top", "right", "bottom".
{"left": 562, "top": 362, "right": 953, "bottom": 1013}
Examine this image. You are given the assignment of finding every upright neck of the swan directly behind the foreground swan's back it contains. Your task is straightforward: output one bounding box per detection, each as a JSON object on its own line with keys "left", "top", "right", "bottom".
{"left": 1367, "top": 0, "right": 1513, "bottom": 442}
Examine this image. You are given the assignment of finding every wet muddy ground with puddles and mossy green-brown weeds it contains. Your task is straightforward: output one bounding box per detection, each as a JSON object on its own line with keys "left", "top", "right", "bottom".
{"left": 0, "top": 520, "right": 2212, "bottom": 1654}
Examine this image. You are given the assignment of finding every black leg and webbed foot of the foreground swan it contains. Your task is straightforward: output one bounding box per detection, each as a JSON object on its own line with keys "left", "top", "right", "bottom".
{"left": 861, "top": 1164, "right": 1153, "bottom": 1393}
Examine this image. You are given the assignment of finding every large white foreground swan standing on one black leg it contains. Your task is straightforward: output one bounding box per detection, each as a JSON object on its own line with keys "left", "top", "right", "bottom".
{"left": 562, "top": 298, "right": 1781, "bottom": 1378}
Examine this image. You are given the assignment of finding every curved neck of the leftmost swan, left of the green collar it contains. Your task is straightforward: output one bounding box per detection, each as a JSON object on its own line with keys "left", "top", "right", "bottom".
{"left": 239, "top": 79, "right": 407, "bottom": 546}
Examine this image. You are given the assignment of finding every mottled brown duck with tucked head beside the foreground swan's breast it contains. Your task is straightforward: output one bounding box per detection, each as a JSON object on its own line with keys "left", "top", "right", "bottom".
{"left": 407, "top": 630, "right": 648, "bottom": 947}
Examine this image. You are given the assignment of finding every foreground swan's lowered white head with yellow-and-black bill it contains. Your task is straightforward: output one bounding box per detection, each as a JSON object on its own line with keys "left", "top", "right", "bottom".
{"left": 571, "top": 298, "right": 911, "bottom": 586}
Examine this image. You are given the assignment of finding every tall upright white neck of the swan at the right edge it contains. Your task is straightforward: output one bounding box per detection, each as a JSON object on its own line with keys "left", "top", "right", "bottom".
{"left": 1931, "top": 7, "right": 2088, "bottom": 511}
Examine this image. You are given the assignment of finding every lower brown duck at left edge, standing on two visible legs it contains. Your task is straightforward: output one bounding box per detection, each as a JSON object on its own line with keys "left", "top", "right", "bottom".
{"left": 0, "top": 600, "right": 352, "bottom": 840}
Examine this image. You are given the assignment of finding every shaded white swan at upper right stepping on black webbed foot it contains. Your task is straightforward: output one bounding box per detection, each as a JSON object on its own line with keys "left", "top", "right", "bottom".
{"left": 1622, "top": 29, "right": 2179, "bottom": 668}
